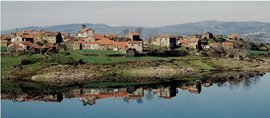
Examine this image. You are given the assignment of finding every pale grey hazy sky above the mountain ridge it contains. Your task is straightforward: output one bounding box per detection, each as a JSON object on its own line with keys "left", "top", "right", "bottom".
{"left": 1, "top": 1, "right": 270, "bottom": 30}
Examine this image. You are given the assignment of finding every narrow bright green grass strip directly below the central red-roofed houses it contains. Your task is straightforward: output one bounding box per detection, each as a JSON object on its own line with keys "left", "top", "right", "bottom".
{"left": 80, "top": 50, "right": 124, "bottom": 55}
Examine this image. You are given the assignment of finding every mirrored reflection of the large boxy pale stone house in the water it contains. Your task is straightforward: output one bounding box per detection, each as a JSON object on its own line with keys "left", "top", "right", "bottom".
{"left": 152, "top": 86, "right": 177, "bottom": 99}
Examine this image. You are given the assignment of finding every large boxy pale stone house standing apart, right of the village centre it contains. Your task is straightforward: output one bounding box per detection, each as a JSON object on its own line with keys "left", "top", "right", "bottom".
{"left": 151, "top": 34, "right": 177, "bottom": 49}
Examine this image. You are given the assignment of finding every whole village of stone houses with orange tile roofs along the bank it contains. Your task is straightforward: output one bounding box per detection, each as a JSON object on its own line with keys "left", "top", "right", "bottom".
{"left": 1, "top": 25, "right": 270, "bottom": 58}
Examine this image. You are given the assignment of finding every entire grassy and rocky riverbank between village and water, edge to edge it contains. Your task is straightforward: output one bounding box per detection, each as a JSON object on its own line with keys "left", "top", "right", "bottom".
{"left": 1, "top": 55, "right": 270, "bottom": 86}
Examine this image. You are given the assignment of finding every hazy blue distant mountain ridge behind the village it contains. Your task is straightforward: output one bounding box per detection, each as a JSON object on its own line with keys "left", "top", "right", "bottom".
{"left": 1, "top": 21, "right": 270, "bottom": 42}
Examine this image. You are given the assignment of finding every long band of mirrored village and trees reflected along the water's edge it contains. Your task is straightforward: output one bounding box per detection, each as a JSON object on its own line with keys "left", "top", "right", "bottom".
{"left": 1, "top": 74, "right": 262, "bottom": 106}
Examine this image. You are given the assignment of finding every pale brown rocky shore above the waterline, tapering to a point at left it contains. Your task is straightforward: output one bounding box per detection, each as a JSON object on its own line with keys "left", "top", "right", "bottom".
{"left": 25, "top": 58, "right": 270, "bottom": 86}
